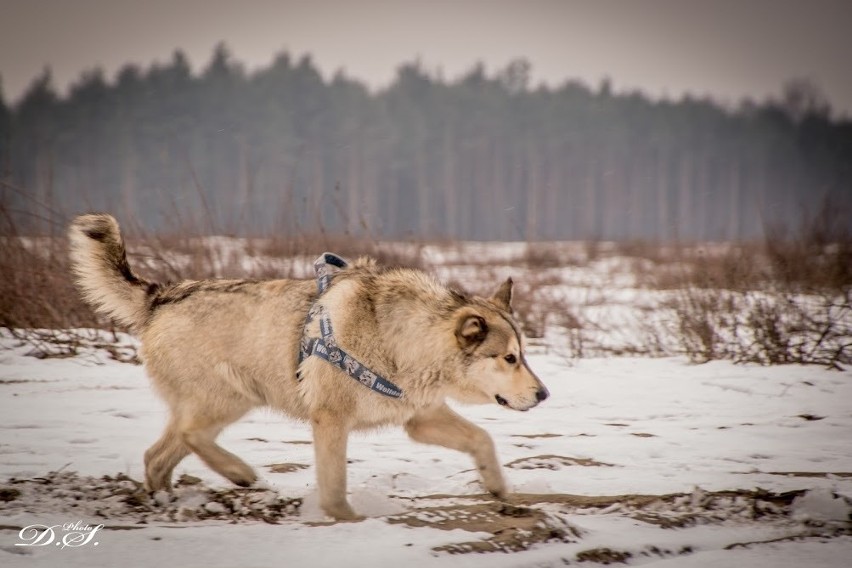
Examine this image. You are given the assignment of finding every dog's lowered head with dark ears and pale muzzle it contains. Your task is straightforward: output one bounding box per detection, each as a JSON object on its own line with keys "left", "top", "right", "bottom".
{"left": 450, "top": 278, "right": 549, "bottom": 410}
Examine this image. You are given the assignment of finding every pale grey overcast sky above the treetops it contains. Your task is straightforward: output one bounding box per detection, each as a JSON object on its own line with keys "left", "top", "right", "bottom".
{"left": 0, "top": 0, "right": 852, "bottom": 116}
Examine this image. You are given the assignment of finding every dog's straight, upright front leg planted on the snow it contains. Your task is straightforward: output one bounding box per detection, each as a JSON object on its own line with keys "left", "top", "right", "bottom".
{"left": 311, "top": 410, "right": 362, "bottom": 521}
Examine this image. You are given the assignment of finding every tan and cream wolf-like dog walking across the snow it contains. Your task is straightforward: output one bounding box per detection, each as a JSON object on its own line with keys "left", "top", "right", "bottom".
{"left": 69, "top": 214, "right": 548, "bottom": 520}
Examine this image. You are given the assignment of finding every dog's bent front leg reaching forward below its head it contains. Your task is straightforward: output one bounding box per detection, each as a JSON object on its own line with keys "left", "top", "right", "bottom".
{"left": 405, "top": 404, "right": 506, "bottom": 499}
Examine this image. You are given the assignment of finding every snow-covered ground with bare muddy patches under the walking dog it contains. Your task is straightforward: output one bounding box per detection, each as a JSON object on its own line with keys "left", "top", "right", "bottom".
{"left": 0, "top": 335, "right": 852, "bottom": 568}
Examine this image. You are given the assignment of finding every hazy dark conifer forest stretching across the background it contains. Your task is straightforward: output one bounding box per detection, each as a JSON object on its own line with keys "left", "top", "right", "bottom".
{"left": 0, "top": 45, "right": 852, "bottom": 240}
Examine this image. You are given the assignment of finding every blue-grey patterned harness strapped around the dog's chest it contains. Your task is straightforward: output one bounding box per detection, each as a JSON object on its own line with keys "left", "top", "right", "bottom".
{"left": 296, "top": 252, "right": 402, "bottom": 398}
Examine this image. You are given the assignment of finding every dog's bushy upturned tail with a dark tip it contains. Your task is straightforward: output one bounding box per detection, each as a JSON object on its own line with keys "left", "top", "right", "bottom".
{"left": 68, "top": 213, "right": 157, "bottom": 329}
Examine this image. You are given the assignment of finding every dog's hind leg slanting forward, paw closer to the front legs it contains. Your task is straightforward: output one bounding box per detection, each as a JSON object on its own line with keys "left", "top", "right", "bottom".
{"left": 178, "top": 405, "right": 257, "bottom": 487}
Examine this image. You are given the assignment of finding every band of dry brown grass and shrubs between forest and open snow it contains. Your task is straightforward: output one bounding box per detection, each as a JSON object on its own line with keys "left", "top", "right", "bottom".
{"left": 0, "top": 191, "right": 852, "bottom": 367}
